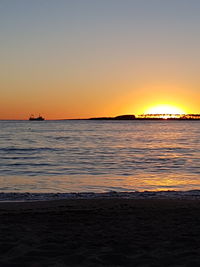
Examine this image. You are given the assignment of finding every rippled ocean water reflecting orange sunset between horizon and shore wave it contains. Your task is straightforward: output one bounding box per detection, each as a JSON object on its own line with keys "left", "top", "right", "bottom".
{"left": 0, "top": 120, "right": 200, "bottom": 192}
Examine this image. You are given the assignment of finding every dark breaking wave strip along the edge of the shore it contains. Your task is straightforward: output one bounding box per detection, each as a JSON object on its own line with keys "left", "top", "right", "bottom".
{"left": 0, "top": 190, "right": 200, "bottom": 202}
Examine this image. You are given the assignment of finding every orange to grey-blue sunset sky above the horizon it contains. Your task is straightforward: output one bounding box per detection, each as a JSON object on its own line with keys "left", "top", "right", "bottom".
{"left": 0, "top": 0, "right": 200, "bottom": 119}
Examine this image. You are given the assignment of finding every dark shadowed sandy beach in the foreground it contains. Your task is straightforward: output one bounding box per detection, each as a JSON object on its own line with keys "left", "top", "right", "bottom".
{"left": 0, "top": 199, "right": 200, "bottom": 267}
